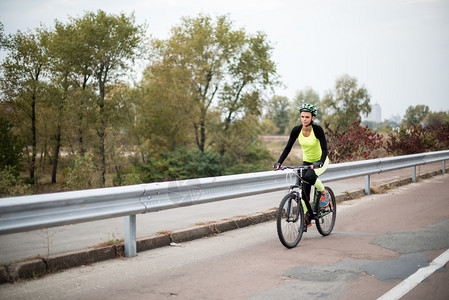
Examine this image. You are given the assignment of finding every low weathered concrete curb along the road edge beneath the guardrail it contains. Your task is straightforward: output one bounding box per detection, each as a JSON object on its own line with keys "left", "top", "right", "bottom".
{"left": 0, "top": 171, "right": 442, "bottom": 284}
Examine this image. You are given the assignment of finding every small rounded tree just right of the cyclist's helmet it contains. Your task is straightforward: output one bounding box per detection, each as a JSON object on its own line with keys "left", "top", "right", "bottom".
{"left": 321, "top": 75, "right": 371, "bottom": 128}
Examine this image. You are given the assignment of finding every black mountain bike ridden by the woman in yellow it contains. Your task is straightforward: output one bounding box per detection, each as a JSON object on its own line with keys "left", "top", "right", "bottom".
{"left": 276, "top": 166, "right": 337, "bottom": 248}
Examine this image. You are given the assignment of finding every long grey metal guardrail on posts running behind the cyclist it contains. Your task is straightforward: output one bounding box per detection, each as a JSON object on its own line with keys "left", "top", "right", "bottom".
{"left": 0, "top": 150, "right": 449, "bottom": 257}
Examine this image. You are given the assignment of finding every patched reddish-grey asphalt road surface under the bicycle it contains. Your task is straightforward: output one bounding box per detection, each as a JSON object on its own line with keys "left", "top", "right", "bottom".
{"left": 0, "top": 174, "right": 449, "bottom": 299}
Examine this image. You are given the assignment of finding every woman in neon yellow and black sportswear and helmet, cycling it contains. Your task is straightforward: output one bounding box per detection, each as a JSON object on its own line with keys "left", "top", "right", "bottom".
{"left": 274, "top": 104, "right": 329, "bottom": 225}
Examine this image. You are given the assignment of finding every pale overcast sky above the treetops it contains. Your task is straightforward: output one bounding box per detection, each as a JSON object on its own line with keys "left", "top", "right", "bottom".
{"left": 0, "top": 0, "right": 449, "bottom": 119}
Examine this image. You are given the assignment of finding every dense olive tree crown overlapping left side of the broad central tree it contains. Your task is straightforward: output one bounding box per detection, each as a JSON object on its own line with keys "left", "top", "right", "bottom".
{"left": 135, "top": 61, "right": 196, "bottom": 151}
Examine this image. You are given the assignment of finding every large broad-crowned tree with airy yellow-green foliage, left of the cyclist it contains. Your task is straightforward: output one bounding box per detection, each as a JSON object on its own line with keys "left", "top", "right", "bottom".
{"left": 151, "top": 15, "right": 278, "bottom": 154}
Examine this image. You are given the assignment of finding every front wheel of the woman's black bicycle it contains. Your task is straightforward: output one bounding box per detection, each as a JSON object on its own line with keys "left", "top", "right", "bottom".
{"left": 276, "top": 193, "right": 304, "bottom": 248}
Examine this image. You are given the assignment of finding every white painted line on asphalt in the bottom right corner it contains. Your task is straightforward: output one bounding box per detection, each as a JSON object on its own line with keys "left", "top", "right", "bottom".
{"left": 378, "top": 249, "right": 449, "bottom": 300}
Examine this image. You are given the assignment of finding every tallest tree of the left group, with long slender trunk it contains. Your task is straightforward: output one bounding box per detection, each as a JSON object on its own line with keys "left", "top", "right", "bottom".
{"left": 72, "top": 10, "right": 144, "bottom": 186}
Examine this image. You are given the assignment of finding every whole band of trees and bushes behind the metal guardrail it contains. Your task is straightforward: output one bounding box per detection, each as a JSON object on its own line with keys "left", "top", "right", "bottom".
{"left": 0, "top": 10, "right": 449, "bottom": 197}
